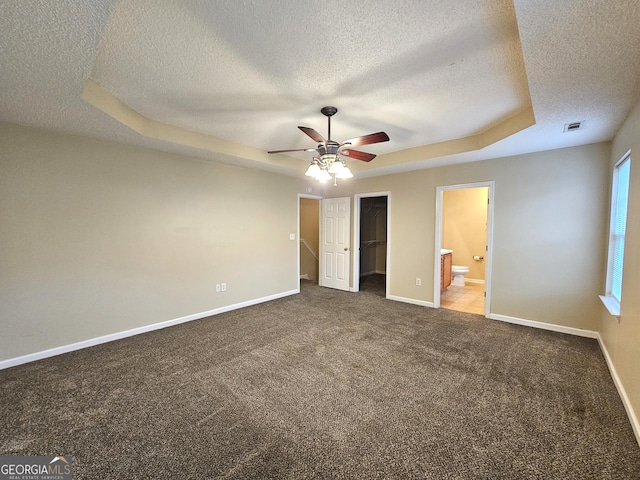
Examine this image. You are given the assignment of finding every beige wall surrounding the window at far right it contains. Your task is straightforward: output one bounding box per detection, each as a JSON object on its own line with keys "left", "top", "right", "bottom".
{"left": 598, "top": 97, "right": 640, "bottom": 432}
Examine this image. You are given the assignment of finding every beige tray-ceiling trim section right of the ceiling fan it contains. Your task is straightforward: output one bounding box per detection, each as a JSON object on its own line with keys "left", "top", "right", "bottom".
{"left": 352, "top": 106, "right": 536, "bottom": 171}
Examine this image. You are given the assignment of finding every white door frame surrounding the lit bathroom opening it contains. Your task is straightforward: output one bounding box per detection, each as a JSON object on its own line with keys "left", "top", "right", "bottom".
{"left": 433, "top": 180, "right": 496, "bottom": 318}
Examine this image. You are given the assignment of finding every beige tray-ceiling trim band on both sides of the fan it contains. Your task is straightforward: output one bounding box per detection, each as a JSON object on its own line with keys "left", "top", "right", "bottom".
{"left": 82, "top": 80, "right": 536, "bottom": 175}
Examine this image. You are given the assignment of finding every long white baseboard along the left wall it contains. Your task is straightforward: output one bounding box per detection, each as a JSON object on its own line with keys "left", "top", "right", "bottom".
{"left": 0, "top": 289, "right": 300, "bottom": 370}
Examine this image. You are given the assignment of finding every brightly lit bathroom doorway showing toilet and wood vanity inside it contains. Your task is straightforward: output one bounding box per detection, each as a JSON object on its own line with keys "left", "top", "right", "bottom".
{"left": 434, "top": 182, "right": 493, "bottom": 316}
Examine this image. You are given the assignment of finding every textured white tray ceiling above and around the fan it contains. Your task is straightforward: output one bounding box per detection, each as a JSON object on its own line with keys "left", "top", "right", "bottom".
{"left": 0, "top": 0, "right": 640, "bottom": 176}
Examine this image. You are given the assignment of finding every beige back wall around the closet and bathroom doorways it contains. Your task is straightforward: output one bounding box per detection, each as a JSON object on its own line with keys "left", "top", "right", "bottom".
{"left": 331, "top": 143, "right": 610, "bottom": 330}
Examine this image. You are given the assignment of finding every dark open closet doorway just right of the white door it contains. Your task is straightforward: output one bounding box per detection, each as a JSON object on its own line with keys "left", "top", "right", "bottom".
{"left": 354, "top": 192, "right": 389, "bottom": 298}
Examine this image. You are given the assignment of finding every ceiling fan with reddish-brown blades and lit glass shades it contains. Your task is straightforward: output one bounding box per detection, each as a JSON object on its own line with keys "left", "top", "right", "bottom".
{"left": 267, "top": 107, "right": 389, "bottom": 184}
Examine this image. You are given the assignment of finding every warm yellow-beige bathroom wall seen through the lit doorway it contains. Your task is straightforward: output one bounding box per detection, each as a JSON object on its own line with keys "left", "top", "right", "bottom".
{"left": 442, "top": 187, "right": 489, "bottom": 281}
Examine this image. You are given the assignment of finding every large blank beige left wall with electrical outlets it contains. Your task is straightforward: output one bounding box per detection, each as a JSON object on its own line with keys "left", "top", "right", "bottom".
{"left": 0, "top": 124, "right": 307, "bottom": 360}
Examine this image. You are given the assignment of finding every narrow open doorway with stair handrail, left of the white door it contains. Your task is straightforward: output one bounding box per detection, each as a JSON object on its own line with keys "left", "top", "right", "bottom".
{"left": 298, "top": 195, "right": 321, "bottom": 283}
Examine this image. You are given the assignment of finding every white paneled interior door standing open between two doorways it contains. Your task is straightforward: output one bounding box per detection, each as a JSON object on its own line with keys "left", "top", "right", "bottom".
{"left": 319, "top": 197, "right": 351, "bottom": 291}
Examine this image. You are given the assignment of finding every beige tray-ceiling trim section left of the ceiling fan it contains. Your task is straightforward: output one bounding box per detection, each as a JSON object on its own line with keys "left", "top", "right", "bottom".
{"left": 82, "top": 79, "right": 301, "bottom": 169}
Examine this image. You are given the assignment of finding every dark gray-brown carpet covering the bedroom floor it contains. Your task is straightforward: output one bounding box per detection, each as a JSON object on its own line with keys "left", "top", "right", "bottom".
{"left": 0, "top": 282, "right": 640, "bottom": 479}
